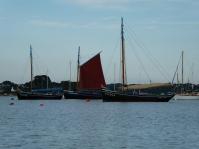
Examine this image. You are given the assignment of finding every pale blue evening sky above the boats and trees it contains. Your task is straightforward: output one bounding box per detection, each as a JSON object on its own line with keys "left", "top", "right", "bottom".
{"left": 0, "top": 0, "right": 199, "bottom": 83}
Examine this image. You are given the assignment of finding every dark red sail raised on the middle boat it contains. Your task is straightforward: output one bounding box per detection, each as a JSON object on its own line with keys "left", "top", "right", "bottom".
{"left": 79, "top": 53, "right": 106, "bottom": 90}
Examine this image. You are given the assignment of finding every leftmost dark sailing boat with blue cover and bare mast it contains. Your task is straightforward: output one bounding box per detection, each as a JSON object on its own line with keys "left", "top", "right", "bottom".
{"left": 17, "top": 45, "right": 63, "bottom": 100}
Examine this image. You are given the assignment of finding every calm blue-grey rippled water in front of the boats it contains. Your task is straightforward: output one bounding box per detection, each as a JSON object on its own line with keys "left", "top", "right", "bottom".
{"left": 0, "top": 97, "right": 199, "bottom": 149}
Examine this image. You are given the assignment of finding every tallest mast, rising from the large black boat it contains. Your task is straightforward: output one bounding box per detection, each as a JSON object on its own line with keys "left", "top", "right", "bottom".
{"left": 121, "top": 18, "right": 127, "bottom": 91}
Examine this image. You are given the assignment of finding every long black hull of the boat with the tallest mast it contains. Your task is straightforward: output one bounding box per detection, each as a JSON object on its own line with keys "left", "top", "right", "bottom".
{"left": 102, "top": 91, "right": 174, "bottom": 102}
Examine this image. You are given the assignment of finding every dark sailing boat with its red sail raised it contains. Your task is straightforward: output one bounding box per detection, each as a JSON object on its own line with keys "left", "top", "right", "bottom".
{"left": 64, "top": 47, "right": 106, "bottom": 99}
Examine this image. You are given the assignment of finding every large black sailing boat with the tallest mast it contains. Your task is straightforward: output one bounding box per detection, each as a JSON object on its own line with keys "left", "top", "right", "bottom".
{"left": 102, "top": 18, "right": 174, "bottom": 102}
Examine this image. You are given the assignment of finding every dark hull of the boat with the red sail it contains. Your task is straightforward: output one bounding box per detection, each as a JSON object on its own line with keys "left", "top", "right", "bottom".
{"left": 64, "top": 92, "right": 102, "bottom": 100}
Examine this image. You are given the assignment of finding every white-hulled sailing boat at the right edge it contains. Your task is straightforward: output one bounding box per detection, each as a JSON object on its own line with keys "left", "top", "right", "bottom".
{"left": 174, "top": 51, "right": 199, "bottom": 100}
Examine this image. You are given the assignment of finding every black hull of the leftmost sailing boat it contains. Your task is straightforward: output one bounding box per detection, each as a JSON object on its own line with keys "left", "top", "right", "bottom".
{"left": 17, "top": 93, "right": 62, "bottom": 100}
